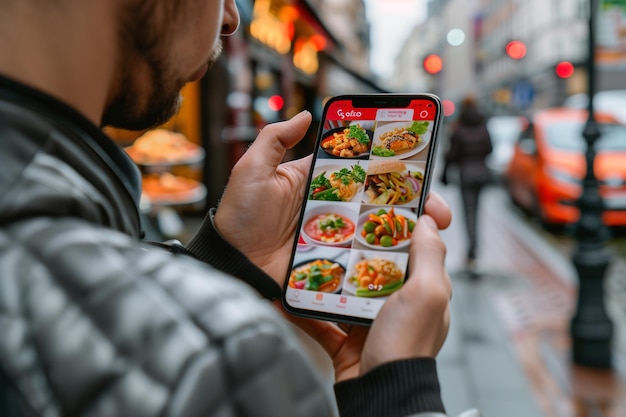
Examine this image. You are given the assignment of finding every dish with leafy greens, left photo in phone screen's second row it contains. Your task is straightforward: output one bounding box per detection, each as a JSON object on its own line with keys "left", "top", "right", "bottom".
{"left": 308, "top": 164, "right": 366, "bottom": 201}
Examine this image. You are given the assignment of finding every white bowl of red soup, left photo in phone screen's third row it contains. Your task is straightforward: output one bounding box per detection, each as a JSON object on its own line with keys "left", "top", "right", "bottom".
{"left": 301, "top": 204, "right": 356, "bottom": 246}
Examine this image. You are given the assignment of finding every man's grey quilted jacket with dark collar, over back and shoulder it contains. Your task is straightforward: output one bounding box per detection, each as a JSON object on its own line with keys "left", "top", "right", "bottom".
{"left": 0, "top": 77, "right": 333, "bottom": 417}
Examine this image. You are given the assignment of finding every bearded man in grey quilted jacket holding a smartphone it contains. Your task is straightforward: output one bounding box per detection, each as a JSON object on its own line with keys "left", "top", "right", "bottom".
{"left": 0, "top": 0, "right": 464, "bottom": 417}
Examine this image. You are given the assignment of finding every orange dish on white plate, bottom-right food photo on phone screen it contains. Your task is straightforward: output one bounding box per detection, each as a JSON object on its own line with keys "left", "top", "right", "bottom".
{"left": 346, "top": 257, "right": 404, "bottom": 297}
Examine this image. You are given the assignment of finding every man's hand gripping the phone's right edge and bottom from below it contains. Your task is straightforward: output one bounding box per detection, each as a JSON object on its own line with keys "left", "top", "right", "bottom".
{"left": 277, "top": 206, "right": 452, "bottom": 382}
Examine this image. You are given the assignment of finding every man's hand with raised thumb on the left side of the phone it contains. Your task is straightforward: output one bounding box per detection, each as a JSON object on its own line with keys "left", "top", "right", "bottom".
{"left": 215, "top": 111, "right": 311, "bottom": 286}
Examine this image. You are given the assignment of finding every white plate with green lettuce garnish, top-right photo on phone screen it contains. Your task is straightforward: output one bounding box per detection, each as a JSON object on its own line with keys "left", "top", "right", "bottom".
{"left": 371, "top": 120, "right": 430, "bottom": 159}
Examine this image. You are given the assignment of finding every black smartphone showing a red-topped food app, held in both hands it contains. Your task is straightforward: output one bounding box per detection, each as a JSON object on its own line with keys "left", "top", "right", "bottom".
{"left": 282, "top": 93, "right": 443, "bottom": 325}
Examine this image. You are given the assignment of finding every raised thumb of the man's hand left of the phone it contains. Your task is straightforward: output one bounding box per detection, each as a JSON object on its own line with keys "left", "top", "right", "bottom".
{"left": 245, "top": 110, "right": 311, "bottom": 169}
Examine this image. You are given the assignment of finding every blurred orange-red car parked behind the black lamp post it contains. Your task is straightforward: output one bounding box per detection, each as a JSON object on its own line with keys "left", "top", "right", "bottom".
{"left": 505, "top": 108, "right": 626, "bottom": 226}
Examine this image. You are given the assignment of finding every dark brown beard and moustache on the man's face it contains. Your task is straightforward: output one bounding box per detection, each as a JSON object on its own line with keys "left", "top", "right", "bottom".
{"left": 101, "top": 0, "right": 222, "bottom": 131}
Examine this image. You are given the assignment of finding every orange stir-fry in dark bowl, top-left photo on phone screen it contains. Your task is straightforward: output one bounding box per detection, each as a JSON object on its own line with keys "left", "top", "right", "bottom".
{"left": 320, "top": 124, "right": 373, "bottom": 158}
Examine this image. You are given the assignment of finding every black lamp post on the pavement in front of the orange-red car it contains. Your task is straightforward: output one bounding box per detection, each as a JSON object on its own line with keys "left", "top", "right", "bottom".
{"left": 570, "top": 0, "right": 613, "bottom": 368}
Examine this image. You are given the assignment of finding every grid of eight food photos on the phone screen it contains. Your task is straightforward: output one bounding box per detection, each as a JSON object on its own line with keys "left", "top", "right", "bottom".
{"left": 288, "top": 114, "right": 433, "bottom": 308}
